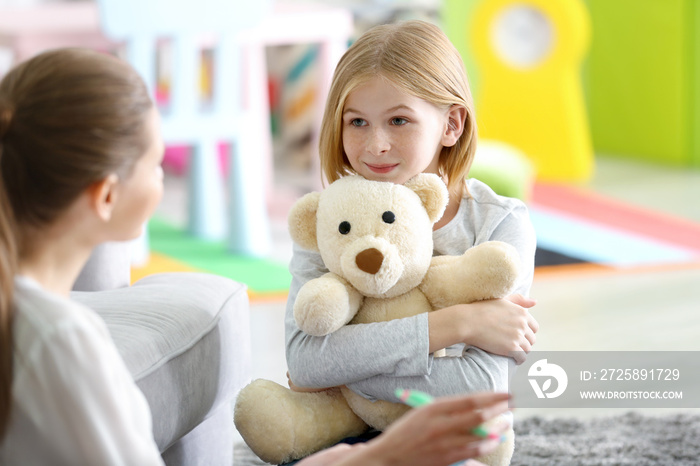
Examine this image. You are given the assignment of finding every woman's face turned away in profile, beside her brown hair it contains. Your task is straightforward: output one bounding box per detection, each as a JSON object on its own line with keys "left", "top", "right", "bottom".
{"left": 112, "top": 108, "right": 165, "bottom": 241}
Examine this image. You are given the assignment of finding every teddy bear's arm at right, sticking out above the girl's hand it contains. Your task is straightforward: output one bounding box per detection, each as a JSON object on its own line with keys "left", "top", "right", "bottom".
{"left": 420, "top": 241, "right": 520, "bottom": 309}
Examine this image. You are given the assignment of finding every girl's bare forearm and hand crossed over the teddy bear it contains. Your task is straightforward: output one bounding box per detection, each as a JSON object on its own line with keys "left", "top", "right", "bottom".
{"left": 428, "top": 294, "right": 539, "bottom": 364}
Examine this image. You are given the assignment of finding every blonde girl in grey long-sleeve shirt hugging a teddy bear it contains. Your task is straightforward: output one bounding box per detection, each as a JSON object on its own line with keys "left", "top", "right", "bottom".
{"left": 285, "top": 21, "right": 538, "bottom": 462}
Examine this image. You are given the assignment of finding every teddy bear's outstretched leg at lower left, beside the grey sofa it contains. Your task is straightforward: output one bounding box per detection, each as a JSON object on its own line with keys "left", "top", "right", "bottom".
{"left": 234, "top": 379, "right": 367, "bottom": 464}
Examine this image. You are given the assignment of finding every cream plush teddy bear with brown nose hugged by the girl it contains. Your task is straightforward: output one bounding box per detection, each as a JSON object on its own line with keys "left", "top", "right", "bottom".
{"left": 234, "top": 174, "right": 519, "bottom": 464}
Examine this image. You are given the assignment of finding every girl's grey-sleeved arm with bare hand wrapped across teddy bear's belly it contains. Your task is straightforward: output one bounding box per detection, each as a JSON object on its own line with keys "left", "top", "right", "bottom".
{"left": 285, "top": 255, "right": 537, "bottom": 394}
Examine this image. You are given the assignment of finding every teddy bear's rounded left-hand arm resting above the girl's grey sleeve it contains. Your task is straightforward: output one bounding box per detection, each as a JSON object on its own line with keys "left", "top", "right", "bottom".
{"left": 294, "top": 273, "right": 363, "bottom": 336}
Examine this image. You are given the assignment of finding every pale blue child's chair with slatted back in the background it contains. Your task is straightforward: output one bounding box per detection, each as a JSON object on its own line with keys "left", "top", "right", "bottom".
{"left": 97, "top": 0, "right": 272, "bottom": 256}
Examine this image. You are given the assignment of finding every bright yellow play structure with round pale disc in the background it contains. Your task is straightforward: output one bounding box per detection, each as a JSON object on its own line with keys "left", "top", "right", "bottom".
{"left": 445, "top": 0, "right": 593, "bottom": 182}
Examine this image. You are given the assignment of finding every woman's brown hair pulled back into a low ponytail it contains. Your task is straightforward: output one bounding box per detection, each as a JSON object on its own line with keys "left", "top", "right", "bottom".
{"left": 0, "top": 49, "right": 153, "bottom": 439}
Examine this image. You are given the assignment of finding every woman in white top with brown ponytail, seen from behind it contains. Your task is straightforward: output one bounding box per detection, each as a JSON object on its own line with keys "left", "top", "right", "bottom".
{"left": 0, "top": 49, "right": 163, "bottom": 465}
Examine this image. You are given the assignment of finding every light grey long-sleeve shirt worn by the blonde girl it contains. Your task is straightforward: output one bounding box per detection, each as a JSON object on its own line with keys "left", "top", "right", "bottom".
{"left": 285, "top": 179, "right": 536, "bottom": 401}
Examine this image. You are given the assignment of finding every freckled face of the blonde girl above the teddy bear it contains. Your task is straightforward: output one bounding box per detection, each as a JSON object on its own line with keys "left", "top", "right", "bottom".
{"left": 342, "top": 76, "right": 456, "bottom": 184}
